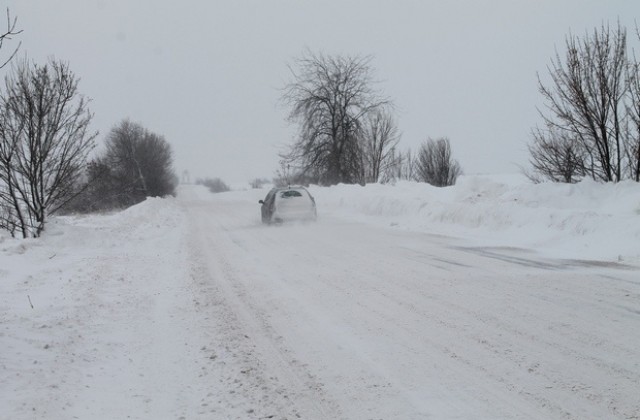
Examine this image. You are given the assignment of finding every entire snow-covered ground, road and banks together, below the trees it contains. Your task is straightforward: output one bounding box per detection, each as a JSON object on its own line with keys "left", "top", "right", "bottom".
{"left": 0, "top": 177, "right": 640, "bottom": 420}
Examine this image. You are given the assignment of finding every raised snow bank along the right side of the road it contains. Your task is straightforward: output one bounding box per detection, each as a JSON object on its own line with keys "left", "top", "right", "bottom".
{"left": 311, "top": 175, "right": 640, "bottom": 260}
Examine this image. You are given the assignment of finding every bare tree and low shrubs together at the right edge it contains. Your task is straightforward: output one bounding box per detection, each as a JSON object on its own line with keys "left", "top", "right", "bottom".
{"left": 529, "top": 24, "right": 640, "bottom": 183}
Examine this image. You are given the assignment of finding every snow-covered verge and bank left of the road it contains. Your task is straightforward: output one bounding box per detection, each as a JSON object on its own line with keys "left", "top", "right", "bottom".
{"left": 0, "top": 198, "right": 202, "bottom": 419}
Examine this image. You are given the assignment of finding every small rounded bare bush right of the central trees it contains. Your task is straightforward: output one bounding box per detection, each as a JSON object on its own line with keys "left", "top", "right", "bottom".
{"left": 416, "top": 138, "right": 462, "bottom": 187}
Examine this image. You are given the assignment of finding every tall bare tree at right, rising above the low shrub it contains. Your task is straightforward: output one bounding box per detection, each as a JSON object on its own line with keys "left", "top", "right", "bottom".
{"left": 538, "top": 25, "right": 627, "bottom": 182}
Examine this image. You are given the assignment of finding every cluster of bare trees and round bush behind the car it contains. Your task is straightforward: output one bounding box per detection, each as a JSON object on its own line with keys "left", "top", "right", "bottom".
{"left": 276, "top": 52, "right": 461, "bottom": 186}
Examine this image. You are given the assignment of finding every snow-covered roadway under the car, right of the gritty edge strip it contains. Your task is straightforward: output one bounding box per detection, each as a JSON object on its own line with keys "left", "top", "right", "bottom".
{"left": 180, "top": 188, "right": 640, "bottom": 419}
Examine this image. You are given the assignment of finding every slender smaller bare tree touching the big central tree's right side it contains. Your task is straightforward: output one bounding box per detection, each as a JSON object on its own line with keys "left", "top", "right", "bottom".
{"left": 362, "top": 109, "right": 400, "bottom": 182}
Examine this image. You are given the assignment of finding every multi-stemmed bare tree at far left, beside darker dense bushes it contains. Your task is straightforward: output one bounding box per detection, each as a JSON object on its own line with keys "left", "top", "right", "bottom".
{"left": 0, "top": 60, "right": 97, "bottom": 238}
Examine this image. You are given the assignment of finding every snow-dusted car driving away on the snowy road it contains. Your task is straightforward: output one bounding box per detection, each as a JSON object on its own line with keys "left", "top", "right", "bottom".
{"left": 258, "top": 186, "right": 318, "bottom": 224}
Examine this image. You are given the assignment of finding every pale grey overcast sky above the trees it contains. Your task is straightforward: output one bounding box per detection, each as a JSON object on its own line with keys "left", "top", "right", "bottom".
{"left": 3, "top": 0, "right": 640, "bottom": 183}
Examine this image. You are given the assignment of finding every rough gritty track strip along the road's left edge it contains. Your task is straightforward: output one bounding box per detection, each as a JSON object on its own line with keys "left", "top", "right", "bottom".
{"left": 182, "top": 200, "right": 340, "bottom": 419}
